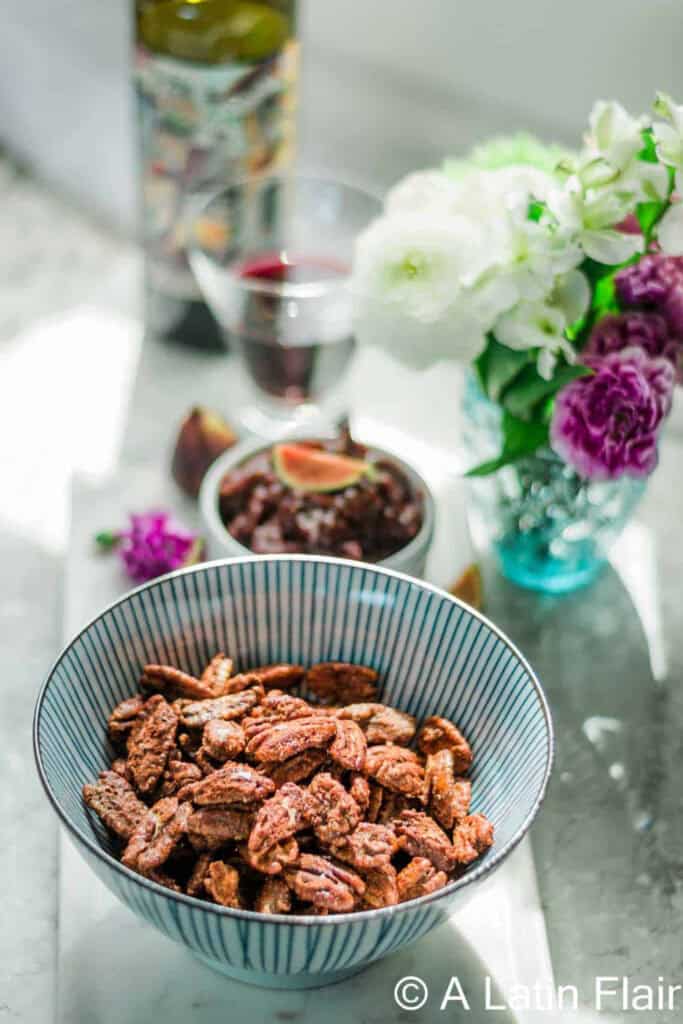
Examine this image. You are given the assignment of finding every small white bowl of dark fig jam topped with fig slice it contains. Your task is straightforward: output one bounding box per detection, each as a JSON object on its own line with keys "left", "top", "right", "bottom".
{"left": 200, "top": 435, "right": 434, "bottom": 577}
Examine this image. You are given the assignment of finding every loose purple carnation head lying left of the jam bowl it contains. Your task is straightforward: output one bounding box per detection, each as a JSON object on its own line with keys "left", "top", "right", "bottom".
{"left": 96, "top": 512, "right": 203, "bottom": 583}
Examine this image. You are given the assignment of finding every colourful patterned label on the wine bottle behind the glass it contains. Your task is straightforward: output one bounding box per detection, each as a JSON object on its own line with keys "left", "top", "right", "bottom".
{"left": 135, "top": 39, "right": 298, "bottom": 300}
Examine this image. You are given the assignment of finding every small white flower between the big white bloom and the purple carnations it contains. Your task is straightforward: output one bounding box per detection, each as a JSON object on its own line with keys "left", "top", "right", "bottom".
{"left": 494, "top": 270, "right": 590, "bottom": 380}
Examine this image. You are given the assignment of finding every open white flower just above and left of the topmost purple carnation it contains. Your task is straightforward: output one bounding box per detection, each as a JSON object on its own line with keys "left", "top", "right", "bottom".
{"left": 548, "top": 178, "right": 644, "bottom": 265}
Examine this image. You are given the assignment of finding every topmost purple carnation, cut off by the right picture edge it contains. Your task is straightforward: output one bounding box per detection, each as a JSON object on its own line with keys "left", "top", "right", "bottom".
{"left": 614, "top": 253, "right": 683, "bottom": 356}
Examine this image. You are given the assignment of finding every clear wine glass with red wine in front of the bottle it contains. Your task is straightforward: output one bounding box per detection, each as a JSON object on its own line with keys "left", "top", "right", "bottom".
{"left": 189, "top": 174, "right": 381, "bottom": 439}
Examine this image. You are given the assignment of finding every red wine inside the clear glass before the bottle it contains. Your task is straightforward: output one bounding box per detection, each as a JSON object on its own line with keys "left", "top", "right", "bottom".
{"left": 231, "top": 252, "right": 354, "bottom": 404}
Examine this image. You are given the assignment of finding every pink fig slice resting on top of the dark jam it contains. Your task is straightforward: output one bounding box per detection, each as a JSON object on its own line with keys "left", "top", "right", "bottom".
{"left": 272, "top": 443, "right": 374, "bottom": 493}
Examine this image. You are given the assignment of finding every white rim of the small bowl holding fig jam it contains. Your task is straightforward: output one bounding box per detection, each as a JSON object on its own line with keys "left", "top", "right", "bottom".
{"left": 199, "top": 431, "right": 436, "bottom": 572}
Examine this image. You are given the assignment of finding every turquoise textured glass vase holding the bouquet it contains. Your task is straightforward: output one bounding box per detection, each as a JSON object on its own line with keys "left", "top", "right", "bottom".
{"left": 464, "top": 376, "right": 645, "bottom": 594}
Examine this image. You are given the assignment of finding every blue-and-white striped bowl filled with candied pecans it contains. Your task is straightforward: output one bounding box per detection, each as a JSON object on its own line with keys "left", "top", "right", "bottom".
{"left": 34, "top": 555, "right": 553, "bottom": 988}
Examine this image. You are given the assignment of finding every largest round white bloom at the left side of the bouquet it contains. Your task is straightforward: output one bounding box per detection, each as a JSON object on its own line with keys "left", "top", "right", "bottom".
{"left": 351, "top": 210, "right": 488, "bottom": 369}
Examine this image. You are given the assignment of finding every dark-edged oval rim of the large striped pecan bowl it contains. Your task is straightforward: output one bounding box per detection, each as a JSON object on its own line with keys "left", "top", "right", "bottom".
{"left": 32, "top": 554, "right": 555, "bottom": 928}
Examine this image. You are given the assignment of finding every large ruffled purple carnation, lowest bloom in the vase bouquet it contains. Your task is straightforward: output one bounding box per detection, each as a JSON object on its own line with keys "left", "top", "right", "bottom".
{"left": 550, "top": 348, "right": 674, "bottom": 480}
